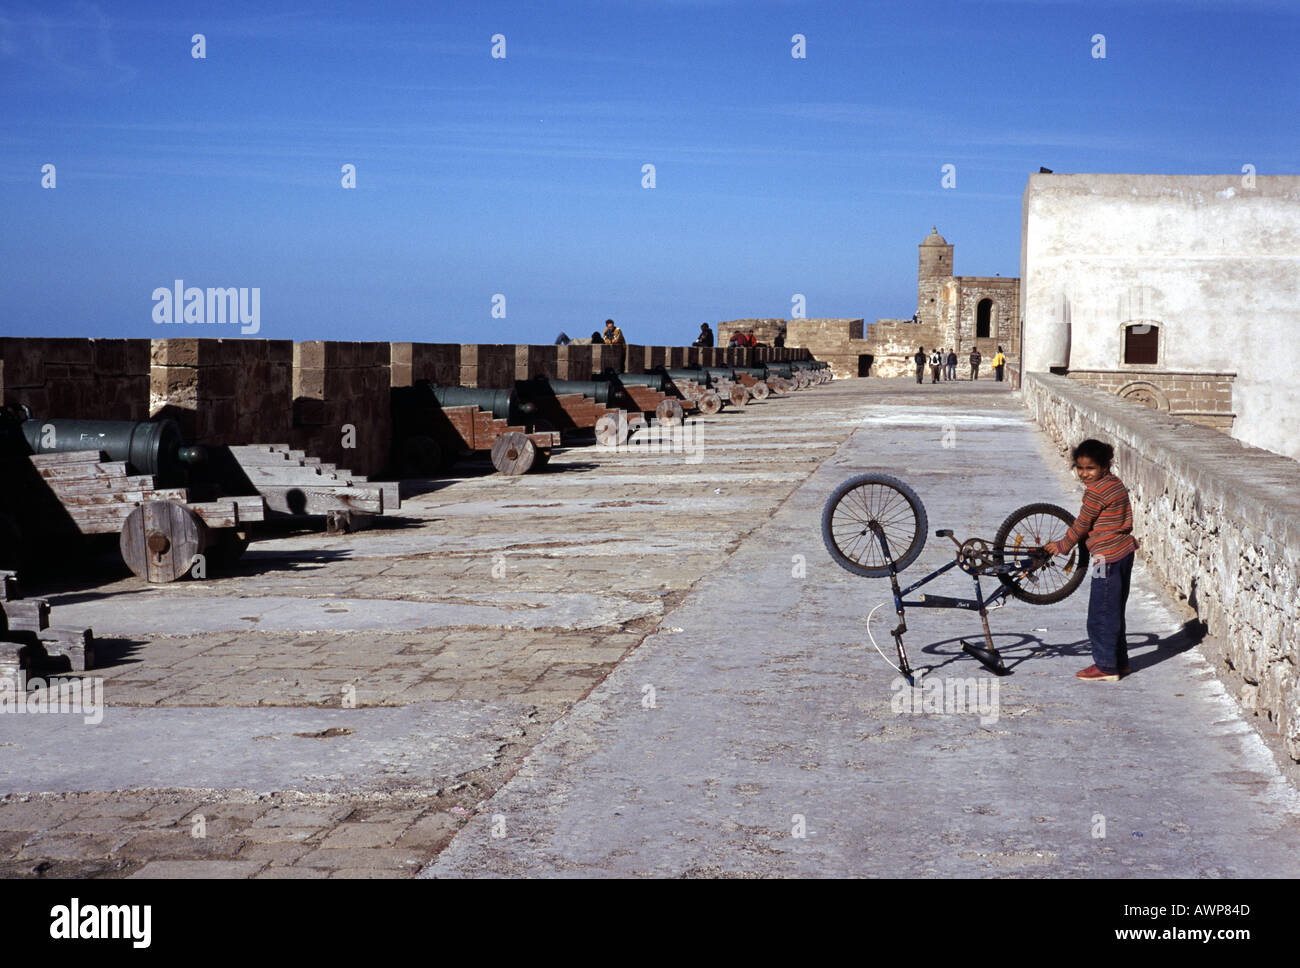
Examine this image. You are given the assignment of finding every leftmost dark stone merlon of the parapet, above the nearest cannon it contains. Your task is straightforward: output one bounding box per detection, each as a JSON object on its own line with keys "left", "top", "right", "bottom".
{"left": 0, "top": 337, "right": 150, "bottom": 420}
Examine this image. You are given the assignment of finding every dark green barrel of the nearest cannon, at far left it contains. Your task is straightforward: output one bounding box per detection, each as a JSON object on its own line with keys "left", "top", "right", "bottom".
{"left": 20, "top": 418, "right": 204, "bottom": 482}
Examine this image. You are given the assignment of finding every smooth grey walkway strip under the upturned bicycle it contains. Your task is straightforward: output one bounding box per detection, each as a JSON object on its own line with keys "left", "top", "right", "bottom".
{"left": 421, "top": 381, "right": 1300, "bottom": 877}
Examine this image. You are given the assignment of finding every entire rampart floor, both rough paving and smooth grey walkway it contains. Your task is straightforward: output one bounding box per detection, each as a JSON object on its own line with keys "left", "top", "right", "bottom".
{"left": 0, "top": 379, "right": 1300, "bottom": 877}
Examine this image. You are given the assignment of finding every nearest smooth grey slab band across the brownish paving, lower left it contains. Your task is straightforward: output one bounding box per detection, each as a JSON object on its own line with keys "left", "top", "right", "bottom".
{"left": 0, "top": 700, "right": 533, "bottom": 794}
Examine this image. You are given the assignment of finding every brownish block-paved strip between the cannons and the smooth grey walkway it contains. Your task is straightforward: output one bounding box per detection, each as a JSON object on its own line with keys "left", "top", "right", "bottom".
{"left": 0, "top": 376, "right": 858, "bottom": 877}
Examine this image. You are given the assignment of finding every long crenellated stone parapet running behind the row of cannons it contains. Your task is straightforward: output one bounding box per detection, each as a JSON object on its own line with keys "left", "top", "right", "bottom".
{"left": 0, "top": 338, "right": 809, "bottom": 476}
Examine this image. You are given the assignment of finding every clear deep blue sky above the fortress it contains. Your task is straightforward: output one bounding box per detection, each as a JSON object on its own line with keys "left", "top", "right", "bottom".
{"left": 0, "top": 0, "right": 1300, "bottom": 343}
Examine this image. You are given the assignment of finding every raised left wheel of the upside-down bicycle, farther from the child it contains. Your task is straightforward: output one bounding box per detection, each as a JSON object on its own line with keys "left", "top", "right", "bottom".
{"left": 822, "top": 474, "right": 930, "bottom": 578}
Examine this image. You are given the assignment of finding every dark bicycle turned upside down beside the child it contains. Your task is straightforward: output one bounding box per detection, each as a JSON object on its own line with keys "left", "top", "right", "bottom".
{"left": 822, "top": 474, "right": 1088, "bottom": 682}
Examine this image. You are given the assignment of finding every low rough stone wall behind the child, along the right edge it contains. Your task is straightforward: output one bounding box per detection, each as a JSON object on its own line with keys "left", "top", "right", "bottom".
{"left": 1023, "top": 373, "right": 1300, "bottom": 761}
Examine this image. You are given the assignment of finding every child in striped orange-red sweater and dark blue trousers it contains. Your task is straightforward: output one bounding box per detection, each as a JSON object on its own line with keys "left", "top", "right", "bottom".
{"left": 1043, "top": 439, "right": 1138, "bottom": 682}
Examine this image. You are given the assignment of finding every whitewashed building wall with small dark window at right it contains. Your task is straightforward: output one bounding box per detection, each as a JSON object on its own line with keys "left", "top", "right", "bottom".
{"left": 1021, "top": 174, "right": 1300, "bottom": 460}
